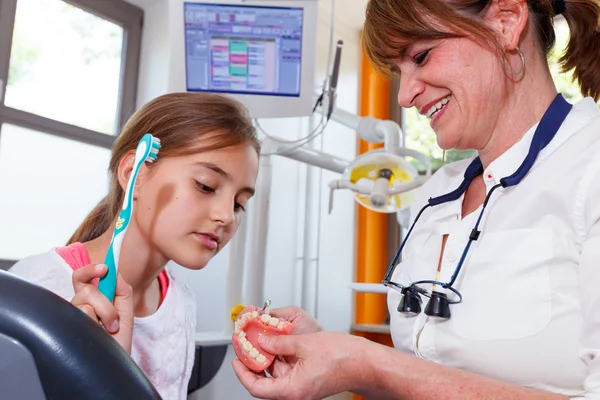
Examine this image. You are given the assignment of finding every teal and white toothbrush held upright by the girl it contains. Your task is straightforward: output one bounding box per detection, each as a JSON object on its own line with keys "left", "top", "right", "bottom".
{"left": 98, "top": 133, "right": 160, "bottom": 302}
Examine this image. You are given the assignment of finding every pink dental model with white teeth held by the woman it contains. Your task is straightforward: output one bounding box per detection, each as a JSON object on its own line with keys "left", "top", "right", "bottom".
{"left": 232, "top": 307, "right": 294, "bottom": 372}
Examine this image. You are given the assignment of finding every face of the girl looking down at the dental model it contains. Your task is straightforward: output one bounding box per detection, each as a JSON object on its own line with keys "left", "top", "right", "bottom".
{"left": 134, "top": 144, "right": 258, "bottom": 269}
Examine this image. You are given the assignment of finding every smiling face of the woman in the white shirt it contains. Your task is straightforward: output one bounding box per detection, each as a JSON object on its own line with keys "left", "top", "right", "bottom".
{"left": 396, "top": 37, "right": 506, "bottom": 150}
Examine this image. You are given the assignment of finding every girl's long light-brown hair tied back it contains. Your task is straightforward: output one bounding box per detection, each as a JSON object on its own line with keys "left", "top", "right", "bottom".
{"left": 67, "top": 93, "right": 260, "bottom": 244}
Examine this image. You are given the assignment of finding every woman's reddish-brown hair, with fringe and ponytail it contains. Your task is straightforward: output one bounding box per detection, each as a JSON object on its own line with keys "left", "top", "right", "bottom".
{"left": 363, "top": 0, "right": 600, "bottom": 101}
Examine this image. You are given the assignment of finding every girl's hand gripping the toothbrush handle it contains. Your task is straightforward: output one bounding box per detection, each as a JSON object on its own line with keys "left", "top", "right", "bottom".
{"left": 71, "top": 264, "right": 133, "bottom": 354}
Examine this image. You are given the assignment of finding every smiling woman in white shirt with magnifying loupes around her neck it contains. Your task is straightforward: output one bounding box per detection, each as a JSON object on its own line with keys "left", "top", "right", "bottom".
{"left": 233, "top": 0, "right": 600, "bottom": 400}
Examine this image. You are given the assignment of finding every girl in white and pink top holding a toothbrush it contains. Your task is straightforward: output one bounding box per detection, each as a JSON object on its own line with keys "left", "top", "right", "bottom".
{"left": 10, "top": 93, "right": 260, "bottom": 399}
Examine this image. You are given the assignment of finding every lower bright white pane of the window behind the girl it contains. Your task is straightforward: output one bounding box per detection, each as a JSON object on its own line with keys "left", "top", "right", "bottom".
{"left": 0, "top": 123, "right": 110, "bottom": 260}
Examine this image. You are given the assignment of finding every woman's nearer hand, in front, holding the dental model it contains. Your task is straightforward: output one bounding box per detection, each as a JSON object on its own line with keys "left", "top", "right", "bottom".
{"left": 233, "top": 332, "right": 374, "bottom": 400}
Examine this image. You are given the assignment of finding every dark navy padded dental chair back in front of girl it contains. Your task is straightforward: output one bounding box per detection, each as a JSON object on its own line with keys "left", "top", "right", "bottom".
{"left": 0, "top": 270, "right": 160, "bottom": 400}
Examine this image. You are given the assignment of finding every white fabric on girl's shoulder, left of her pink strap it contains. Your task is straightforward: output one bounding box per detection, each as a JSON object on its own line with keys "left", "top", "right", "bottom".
{"left": 8, "top": 250, "right": 75, "bottom": 301}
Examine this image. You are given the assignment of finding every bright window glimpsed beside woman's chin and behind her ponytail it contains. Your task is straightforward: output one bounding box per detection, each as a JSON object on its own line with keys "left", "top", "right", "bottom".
{"left": 402, "top": 17, "right": 596, "bottom": 170}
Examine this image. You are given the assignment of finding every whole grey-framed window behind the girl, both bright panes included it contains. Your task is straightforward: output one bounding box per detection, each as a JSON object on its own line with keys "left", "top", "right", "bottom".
{"left": 0, "top": 0, "right": 143, "bottom": 268}
